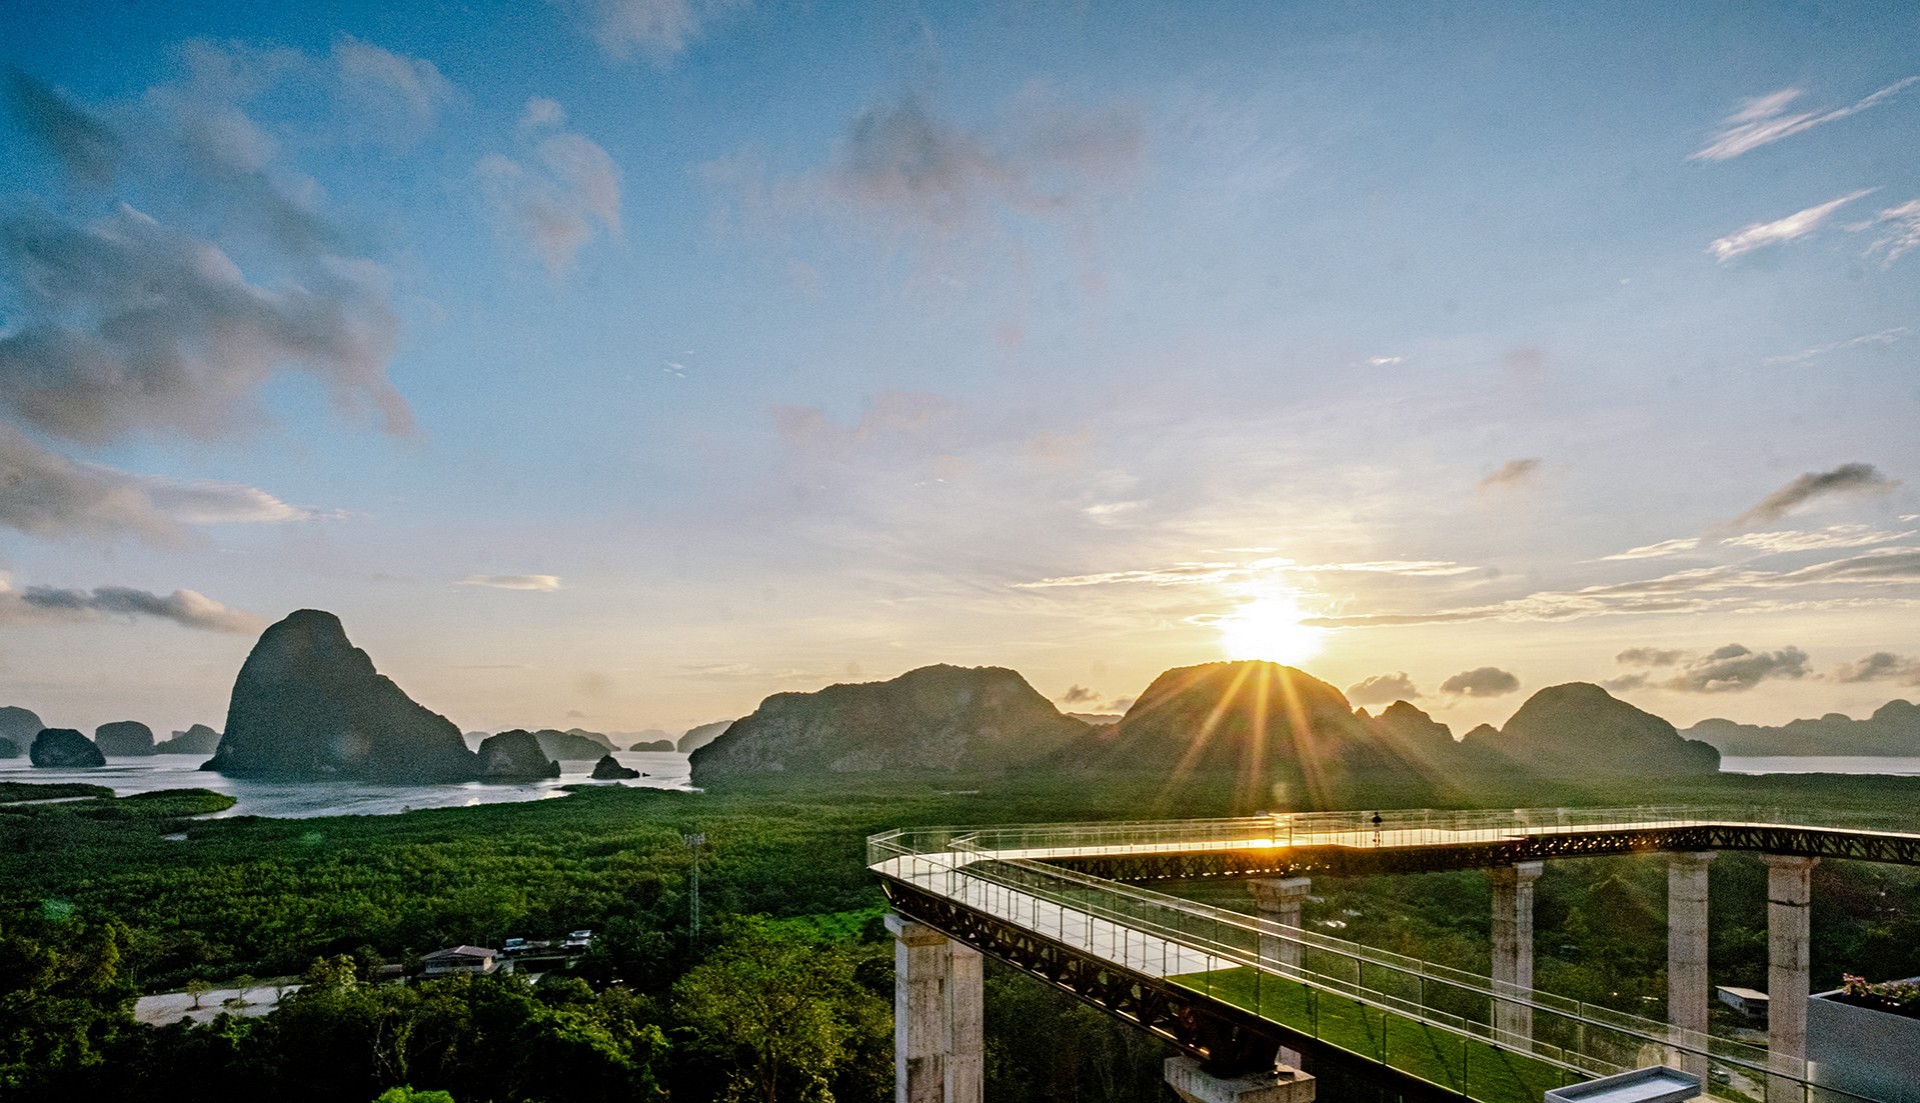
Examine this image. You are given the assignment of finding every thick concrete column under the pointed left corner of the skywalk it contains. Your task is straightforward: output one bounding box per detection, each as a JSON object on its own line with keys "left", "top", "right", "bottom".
{"left": 887, "top": 915, "right": 985, "bottom": 1103}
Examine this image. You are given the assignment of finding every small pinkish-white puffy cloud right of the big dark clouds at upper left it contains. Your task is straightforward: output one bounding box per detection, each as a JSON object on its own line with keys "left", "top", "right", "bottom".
{"left": 474, "top": 96, "right": 620, "bottom": 279}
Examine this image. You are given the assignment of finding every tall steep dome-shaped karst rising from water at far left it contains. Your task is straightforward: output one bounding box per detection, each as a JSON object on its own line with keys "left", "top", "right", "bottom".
{"left": 202, "top": 609, "right": 480, "bottom": 782}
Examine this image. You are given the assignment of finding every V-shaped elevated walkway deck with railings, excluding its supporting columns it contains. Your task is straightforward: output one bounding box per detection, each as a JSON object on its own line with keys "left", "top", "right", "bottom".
{"left": 868, "top": 809, "right": 1920, "bottom": 1103}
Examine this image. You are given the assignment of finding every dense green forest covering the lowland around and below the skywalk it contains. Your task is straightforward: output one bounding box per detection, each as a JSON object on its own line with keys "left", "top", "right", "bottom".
{"left": 0, "top": 778, "right": 1920, "bottom": 1103}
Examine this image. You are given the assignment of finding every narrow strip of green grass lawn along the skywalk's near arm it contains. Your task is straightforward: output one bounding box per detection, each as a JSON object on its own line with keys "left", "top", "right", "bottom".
{"left": 1167, "top": 967, "right": 1584, "bottom": 1103}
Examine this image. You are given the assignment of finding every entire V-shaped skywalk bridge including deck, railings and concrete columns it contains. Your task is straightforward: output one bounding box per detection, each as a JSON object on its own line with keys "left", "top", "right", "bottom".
{"left": 868, "top": 809, "right": 1920, "bottom": 1103}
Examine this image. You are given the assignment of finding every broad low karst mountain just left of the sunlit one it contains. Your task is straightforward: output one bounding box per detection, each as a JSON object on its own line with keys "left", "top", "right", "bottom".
{"left": 693, "top": 665, "right": 1089, "bottom": 784}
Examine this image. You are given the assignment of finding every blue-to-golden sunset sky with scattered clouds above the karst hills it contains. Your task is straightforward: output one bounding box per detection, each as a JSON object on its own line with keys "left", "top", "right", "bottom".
{"left": 0, "top": 0, "right": 1920, "bottom": 745}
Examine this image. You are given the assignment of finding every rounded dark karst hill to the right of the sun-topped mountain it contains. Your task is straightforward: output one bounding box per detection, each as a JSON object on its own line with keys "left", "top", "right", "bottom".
{"left": 1465, "top": 682, "right": 1720, "bottom": 776}
